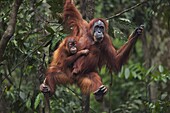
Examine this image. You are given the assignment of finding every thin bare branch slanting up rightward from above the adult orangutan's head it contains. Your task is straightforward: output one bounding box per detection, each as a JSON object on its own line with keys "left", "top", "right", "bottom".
{"left": 106, "top": 0, "right": 147, "bottom": 20}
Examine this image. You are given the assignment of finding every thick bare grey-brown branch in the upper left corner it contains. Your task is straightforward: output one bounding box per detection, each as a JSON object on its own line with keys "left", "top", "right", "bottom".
{"left": 0, "top": 0, "right": 22, "bottom": 62}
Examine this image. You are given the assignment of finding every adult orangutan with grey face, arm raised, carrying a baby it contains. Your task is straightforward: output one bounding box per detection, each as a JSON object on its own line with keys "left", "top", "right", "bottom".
{"left": 64, "top": 0, "right": 143, "bottom": 101}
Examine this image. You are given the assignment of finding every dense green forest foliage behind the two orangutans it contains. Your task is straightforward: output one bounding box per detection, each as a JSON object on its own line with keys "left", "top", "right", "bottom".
{"left": 0, "top": 0, "right": 170, "bottom": 113}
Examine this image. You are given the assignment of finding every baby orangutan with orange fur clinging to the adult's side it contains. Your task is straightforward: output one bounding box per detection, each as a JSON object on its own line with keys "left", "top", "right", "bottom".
{"left": 40, "top": 37, "right": 89, "bottom": 95}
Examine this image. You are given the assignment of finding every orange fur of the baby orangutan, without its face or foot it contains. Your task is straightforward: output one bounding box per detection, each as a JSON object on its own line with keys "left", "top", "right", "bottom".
{"left": 45, "top": 37, "right": 84, "bottom": 94}
